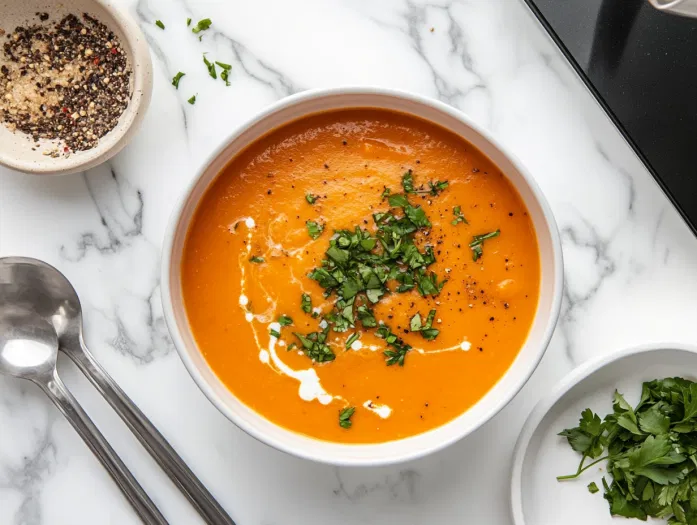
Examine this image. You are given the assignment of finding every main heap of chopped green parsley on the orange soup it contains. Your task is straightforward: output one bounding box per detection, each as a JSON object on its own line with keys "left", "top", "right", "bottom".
{"left": 296, "top": 171, "right": 448, "bottom": 366}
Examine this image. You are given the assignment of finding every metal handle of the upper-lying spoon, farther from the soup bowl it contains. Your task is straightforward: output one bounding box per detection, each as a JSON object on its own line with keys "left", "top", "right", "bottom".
{"left": 38, "top": 371, "right": 168, "bottom": 525}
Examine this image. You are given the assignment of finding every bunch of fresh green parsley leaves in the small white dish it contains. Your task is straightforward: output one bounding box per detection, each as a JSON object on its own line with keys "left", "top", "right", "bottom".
{"left": 557, "top": 378, "right": 697, "bottom": 525}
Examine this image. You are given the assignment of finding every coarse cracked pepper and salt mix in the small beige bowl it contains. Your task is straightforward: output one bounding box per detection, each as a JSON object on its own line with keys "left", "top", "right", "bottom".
{"left": 0, "top": 13, "right": 131, "bottom": 157}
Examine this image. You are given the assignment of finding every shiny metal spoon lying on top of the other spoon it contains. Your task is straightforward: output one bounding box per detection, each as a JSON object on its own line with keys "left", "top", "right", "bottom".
{"left": 0, "top": 304, "right": 167, "bottom": 525}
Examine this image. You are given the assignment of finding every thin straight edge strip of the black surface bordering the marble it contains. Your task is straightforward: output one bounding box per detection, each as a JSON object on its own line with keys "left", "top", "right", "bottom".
{"left": 524, "top": 0, "right": 697, "bottom": 234}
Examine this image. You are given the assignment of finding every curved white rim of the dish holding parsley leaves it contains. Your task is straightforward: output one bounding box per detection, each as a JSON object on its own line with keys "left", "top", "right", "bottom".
{"left": 509, "top": 342, "right": 697, "bottom": 525}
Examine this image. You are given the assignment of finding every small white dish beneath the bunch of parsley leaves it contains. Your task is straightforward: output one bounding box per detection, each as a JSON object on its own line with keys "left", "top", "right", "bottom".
{"left": 511, "top": 344, "right": 697, "bottom": 525}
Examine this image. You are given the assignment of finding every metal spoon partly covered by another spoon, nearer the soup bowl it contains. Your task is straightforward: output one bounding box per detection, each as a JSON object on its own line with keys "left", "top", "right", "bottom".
{"left": 0, "top": 257, "right": 235, "bottom": 525}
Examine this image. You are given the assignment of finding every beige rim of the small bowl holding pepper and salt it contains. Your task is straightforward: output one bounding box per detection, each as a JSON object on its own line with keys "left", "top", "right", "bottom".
{"left": 0, "top": 0, "right": 153, "bottom": 176}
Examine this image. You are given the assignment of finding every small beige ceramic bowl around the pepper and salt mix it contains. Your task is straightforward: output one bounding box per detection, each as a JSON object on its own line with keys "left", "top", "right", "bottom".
{"left": 0, "top": 0, "right": 152, "bottom": 175}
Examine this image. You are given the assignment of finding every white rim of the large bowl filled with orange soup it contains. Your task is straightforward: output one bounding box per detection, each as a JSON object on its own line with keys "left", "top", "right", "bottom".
{"left": 160, "top": 86, "right": 564, "bottom": 466}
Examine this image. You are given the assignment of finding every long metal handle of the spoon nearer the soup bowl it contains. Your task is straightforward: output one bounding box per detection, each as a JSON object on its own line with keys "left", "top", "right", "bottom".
{"left": 61, "top": 340, "right": 235, "bottom": 525}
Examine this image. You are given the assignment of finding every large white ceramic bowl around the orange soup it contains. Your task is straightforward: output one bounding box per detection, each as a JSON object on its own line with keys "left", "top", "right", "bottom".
{"left": 162, "top": 88, "right": 563, "bottom": 465}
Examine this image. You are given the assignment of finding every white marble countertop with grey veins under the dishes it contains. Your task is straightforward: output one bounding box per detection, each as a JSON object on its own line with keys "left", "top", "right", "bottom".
{"left": 0, "top": 0, "right": 697, "bottom": 525}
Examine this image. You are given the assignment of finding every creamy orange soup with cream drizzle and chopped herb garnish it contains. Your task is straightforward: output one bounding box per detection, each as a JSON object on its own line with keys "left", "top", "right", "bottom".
{"left": 181, "top": 109, "right": 540, "bottom": 443}
